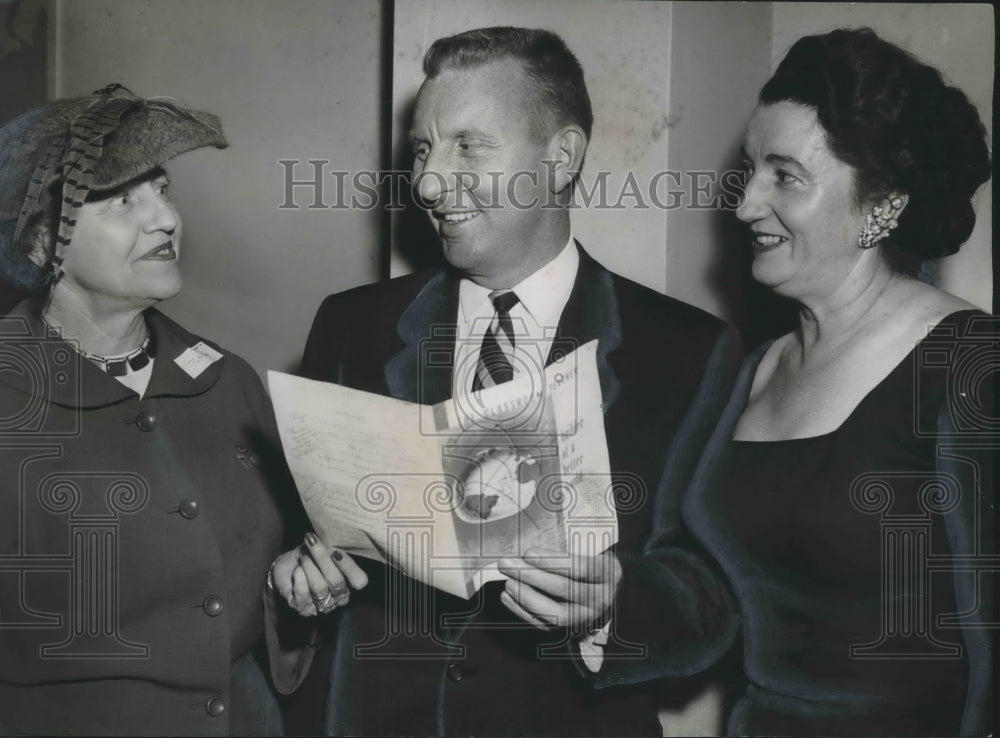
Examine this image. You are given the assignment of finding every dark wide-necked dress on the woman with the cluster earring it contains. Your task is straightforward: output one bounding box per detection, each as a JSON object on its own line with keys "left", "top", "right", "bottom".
{"left": 685, "top": 311, "right": 995, "bottom": 735}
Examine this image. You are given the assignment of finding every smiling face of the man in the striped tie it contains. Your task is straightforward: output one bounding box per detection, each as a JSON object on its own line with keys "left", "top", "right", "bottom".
{"left": 410, "top": 59, "right": 563, "bottom": 288}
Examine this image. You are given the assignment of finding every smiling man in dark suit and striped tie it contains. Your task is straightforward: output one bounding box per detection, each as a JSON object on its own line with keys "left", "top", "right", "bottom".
{"left": 275, "top": 28, "right": 739, "bottom": 735}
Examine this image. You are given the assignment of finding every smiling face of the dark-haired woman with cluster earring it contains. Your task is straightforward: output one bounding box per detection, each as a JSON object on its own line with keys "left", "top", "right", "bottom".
{"left": 736, "top": 102, "right": 864, "bottom": 298}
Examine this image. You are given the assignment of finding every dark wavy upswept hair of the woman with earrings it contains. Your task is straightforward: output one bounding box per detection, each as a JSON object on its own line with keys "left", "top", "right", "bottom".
{"left": 760, "top": 28, "right": 990, "bottom": 274}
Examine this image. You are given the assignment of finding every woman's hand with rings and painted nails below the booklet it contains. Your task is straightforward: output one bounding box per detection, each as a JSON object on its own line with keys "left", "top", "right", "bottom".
{"left": 268, "top": 533, "right": 368, "bottom": 617}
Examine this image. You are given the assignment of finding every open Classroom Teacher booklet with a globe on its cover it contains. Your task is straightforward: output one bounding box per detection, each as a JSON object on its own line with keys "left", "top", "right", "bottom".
{"left": 268, "top": 341, "right": 618, "bottom": 598}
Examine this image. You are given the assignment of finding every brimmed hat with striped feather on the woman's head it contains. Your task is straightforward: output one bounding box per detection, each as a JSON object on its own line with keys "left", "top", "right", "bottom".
{"left": 0, "top": 84, "right": 228, "bottom": 291}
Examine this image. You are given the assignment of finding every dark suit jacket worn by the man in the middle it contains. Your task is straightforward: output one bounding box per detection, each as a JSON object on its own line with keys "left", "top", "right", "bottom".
{"left": 302, "top": 249, "right": 739, "bottom": 735}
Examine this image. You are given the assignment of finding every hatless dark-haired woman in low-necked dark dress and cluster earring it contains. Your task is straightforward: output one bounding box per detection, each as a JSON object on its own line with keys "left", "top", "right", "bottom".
{"left": 685, "top": 29, "right": 1000, "bottom": 735}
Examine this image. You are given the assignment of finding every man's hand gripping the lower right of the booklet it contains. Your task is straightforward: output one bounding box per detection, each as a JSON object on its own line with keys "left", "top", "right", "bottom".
{"left": 498, "top": 549, "right": 622, "bottom": 634}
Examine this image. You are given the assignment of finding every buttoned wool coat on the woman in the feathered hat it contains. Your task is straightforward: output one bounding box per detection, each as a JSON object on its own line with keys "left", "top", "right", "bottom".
{"left": 0, "top": 303, "right": 297, "bottom": 735}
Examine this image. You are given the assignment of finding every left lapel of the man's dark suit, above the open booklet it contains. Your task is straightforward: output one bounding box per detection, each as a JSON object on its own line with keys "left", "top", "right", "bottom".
{"left": 384, "top": 272, "right": 458, "bottom": 405}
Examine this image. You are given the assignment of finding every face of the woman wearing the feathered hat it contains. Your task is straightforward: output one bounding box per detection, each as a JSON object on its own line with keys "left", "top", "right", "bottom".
{"left": 63, "top": 170, "right": 181, "bottom": 307}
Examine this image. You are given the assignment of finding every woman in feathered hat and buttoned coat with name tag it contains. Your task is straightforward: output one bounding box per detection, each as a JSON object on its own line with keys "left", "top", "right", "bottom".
{"left": 0, "top": 85, "right": 297, "bottom": 735}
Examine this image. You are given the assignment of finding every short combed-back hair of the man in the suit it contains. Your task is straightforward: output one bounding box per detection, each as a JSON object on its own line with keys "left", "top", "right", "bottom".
{"left": 424, "top": 26, "right": 594, "bottom": 139}
